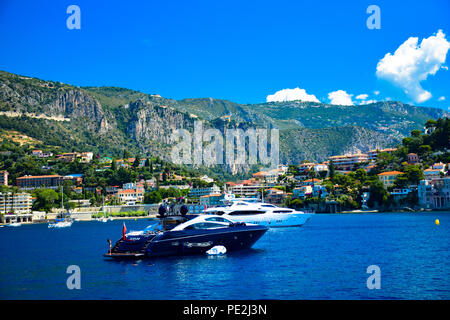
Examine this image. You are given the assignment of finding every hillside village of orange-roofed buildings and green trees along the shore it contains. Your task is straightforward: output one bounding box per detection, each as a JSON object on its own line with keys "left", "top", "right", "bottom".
{"left": 0, "top": 118, "right": 450, "bottom": 223}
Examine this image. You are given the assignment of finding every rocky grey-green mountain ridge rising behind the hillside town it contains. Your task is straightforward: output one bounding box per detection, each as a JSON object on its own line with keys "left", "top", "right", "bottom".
{"left": 0, "top": 71, "right": 449, "bottom": 170}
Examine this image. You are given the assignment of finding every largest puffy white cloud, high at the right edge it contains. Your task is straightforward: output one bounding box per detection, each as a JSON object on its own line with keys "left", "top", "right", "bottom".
{"left": 376, "top": 30, "right": 450, "bottom": 102}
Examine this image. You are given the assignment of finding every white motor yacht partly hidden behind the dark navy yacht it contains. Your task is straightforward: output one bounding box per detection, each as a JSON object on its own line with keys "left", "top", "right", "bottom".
{"left": 205, "top": 199, "right": 313, "bottom": 228}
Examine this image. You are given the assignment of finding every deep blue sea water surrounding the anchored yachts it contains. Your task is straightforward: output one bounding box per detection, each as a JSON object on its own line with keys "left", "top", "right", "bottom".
{"left": 0, "top": 212, "right": 450, "bottom": 299}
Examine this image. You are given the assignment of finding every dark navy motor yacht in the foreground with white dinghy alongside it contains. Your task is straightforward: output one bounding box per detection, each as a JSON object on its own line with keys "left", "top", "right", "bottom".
{"left": 104, "top": 215, "right": 268, "bottom": 259}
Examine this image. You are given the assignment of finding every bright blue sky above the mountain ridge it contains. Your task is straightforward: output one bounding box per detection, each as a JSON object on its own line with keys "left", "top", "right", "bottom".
{"left": 0, "top": 0, "right": 450, "bottom": 110}
